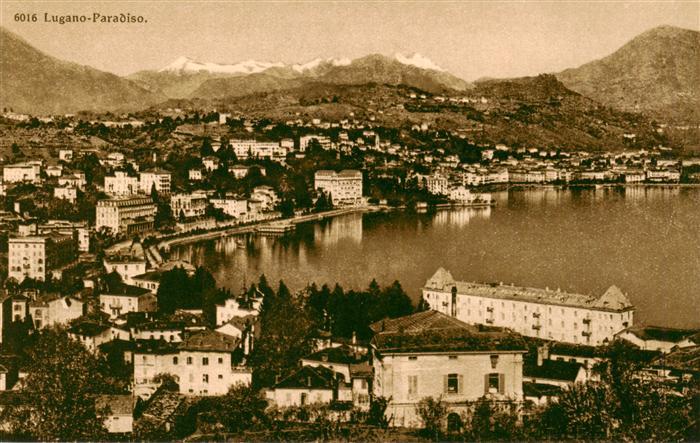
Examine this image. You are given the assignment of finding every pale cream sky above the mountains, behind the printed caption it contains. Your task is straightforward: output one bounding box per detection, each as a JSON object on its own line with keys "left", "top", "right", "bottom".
{"left": 0, "top": 0, "right": 700, "bottom": 80}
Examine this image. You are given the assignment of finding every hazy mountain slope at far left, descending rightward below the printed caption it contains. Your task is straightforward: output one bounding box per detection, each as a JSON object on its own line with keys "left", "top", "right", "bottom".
{"left": 0, "top": 28, "right": 162, "bottom": 114}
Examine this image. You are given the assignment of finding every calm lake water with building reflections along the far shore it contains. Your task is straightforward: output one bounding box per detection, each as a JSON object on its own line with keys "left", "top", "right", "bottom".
{"left": 172, "top": 187, "right": 700, "bottom": 327}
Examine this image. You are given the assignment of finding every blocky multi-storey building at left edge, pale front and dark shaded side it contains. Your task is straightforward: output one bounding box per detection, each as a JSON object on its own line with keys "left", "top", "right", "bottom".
{"left": 7, "top": 233, "right": 77, "bottom": 282}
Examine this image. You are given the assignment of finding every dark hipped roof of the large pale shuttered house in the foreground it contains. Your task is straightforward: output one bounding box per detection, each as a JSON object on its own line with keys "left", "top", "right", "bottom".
{"left": 370, "top": 311, "right": 527, "bottom": 353}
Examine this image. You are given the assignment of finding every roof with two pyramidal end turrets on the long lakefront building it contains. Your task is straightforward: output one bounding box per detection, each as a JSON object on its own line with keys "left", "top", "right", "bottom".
{"left": 425, "top": 268, "right": 633, "bottom": 311}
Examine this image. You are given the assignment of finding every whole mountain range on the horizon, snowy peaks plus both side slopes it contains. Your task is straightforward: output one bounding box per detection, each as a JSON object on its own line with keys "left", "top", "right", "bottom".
{"left": 0, "top": 26, "right": 700, "bottom": 121}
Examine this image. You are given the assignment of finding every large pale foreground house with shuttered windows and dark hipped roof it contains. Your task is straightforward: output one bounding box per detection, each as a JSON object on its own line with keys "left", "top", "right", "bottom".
{"left": 370, "top": 311, "right": 527, "bottom": 427}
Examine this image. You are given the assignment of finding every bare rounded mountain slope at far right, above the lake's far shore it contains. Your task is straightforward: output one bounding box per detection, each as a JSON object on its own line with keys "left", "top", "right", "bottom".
{"left": 556, "top": 26, "right": 700, "bottom": 121}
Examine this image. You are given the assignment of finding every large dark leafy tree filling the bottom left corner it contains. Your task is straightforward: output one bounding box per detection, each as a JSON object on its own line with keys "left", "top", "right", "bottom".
{"left": 0, "top": 329, "right": 114, "bottom": 441}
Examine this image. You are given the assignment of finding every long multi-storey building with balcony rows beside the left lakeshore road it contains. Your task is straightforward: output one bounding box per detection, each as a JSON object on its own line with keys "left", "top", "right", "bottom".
{"left": 95, "top": 196, "right": 156, "bottom": 234}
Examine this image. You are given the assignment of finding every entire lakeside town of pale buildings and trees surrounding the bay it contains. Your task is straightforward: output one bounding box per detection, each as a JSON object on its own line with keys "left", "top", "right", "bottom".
{"left": 0, "top": 106, "right": 700, "bottom": 440}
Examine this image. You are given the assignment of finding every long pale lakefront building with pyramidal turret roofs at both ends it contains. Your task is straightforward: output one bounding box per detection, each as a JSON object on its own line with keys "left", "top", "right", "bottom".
{"left": 423, "top": 268, "right": 634, "bottom": 345}
